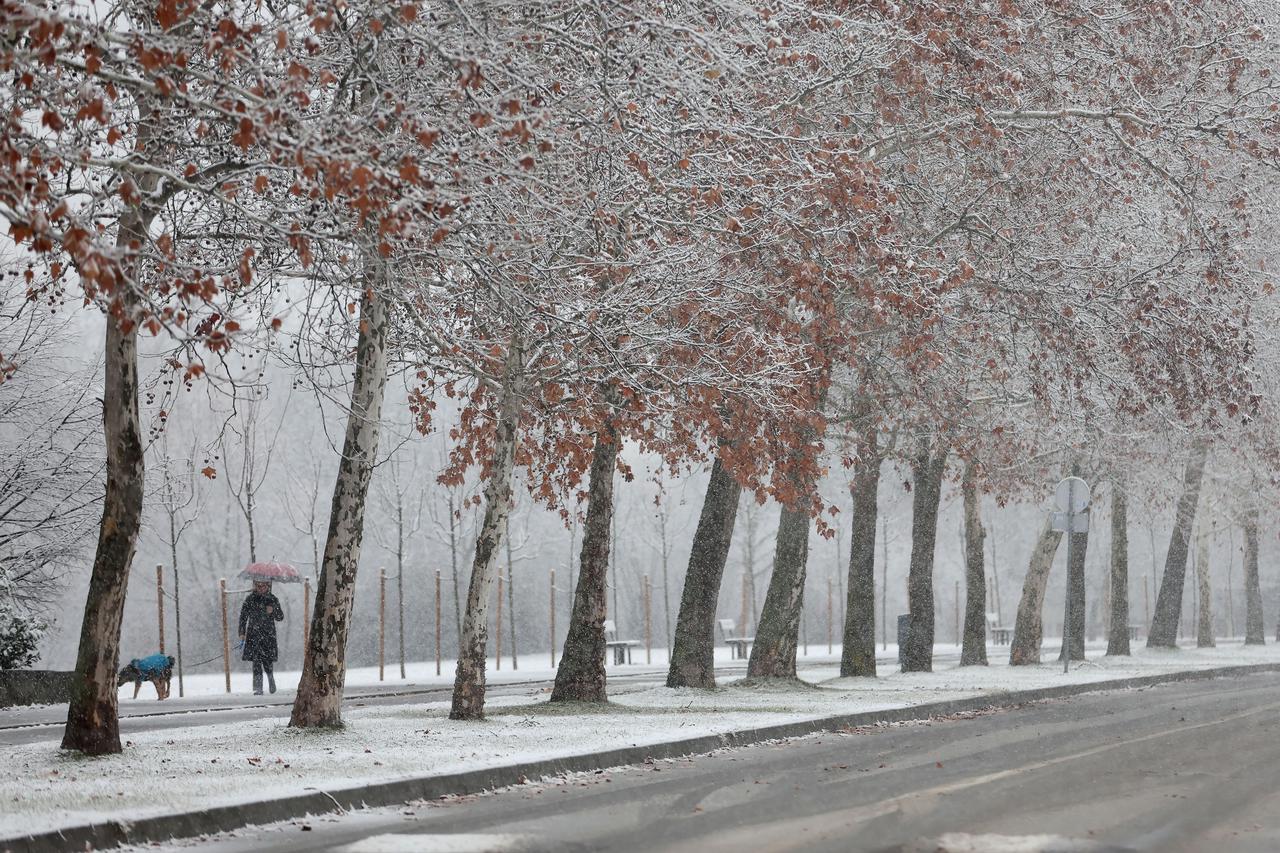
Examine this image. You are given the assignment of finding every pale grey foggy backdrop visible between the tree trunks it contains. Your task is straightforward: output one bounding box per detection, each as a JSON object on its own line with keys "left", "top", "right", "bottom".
{"left": 22, "top": 311, "right": 1277, "bottom": 672}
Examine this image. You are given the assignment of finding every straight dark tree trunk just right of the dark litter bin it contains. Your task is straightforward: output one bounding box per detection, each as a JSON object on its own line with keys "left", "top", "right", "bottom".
{"left": 902, "top": 446, "right": 947, "bottom": 672}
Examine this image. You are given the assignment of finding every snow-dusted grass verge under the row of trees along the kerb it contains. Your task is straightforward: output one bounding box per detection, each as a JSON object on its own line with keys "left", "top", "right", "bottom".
{"left": 0, "top": 642, "right": 1280, "bottom": 838}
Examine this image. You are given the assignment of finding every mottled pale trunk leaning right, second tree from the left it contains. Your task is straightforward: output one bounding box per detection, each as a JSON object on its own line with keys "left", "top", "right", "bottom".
{"left": 289, "top": 281, "right": 388, "bottom": 727}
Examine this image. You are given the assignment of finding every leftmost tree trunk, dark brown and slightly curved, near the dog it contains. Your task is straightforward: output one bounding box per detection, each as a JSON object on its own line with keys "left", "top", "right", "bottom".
{"left": 63, "top": 284, "right": 143, "bottom": 756}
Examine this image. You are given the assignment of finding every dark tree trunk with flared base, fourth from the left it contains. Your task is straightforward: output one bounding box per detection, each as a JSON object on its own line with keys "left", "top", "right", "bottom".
{"left": 552, "top": 392, "right": 618, "bottom": 702}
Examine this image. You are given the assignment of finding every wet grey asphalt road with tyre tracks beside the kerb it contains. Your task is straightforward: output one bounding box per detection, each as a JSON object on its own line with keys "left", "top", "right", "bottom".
{"left": 148, "top": 675, "right": 1280, "bottom": 853}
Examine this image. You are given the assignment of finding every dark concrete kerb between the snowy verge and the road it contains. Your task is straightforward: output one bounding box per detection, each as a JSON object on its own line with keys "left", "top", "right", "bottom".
{"left": 0, "top": 663, "right": 1280, "bottom": 853}
